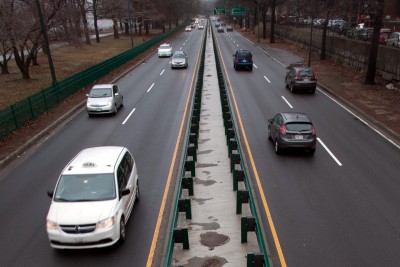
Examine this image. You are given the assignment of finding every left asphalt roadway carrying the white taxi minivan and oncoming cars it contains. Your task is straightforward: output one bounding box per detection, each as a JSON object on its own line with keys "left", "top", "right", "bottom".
{"left": 0, "top": 26, "right": 204, "bottom": 266}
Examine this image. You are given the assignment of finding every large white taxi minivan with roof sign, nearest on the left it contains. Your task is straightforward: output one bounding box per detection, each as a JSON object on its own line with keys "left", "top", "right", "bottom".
{"left": 46, "top": 146, "right": 139, "bottom": 249}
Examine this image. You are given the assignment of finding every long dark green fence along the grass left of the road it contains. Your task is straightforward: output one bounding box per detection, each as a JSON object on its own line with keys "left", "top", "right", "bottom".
{"left": 0, "top": 22, "right": 187, "bottom": 141}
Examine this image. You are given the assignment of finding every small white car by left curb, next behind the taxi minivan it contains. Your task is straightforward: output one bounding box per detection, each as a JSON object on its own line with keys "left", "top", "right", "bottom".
{"left": 86, "top": 84, "right": 124, "bottom": 116}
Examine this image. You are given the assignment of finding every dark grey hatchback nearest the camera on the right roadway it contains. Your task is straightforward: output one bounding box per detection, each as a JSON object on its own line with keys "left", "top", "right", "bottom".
{"left": 268, "top": 112, "right": 317, "bottom": 155}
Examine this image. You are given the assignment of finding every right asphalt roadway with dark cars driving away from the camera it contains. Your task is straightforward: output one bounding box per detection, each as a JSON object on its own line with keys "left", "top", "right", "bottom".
{"left": 217, "top": 26, "right": 400, "bottom": 266}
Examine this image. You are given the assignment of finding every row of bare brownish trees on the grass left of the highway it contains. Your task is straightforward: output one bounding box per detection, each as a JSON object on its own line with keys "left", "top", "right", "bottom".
{"left": 0, "top": 0, "right": 193, "bottom": 79}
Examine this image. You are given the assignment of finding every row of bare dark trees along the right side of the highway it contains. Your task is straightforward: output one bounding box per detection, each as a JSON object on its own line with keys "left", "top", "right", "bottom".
{"left": 212, "top": 0, "right": 384, "bottom": 84}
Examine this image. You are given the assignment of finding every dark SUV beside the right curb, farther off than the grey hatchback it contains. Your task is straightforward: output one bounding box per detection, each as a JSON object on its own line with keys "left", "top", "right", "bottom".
{"left": 285, "top": 66, "right": 317, "bottom": 93}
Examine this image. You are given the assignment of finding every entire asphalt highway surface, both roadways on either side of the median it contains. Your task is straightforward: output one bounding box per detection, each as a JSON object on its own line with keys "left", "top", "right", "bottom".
{"left": 0, "top": 21, "right": 400, "bottom": 266}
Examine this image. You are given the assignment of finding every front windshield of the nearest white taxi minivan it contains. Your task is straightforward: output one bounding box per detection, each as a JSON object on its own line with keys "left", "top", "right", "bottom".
{"left": 54, "top": 173, "right": 116, "bottom": 202}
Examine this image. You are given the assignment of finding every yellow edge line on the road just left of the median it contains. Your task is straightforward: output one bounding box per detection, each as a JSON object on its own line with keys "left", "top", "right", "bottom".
{"left": 146, "top": 31, "right": 205, "bottom": 267}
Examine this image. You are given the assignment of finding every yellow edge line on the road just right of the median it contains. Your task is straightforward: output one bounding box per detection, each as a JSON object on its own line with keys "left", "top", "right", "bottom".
{"left": 217, "top": 34, "right": 287, "bottom": 267}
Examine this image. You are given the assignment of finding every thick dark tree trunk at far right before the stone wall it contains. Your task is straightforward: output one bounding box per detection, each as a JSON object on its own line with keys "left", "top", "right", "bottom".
{"left": 365, "top": 0, "right": 384, "bottom": 85}
